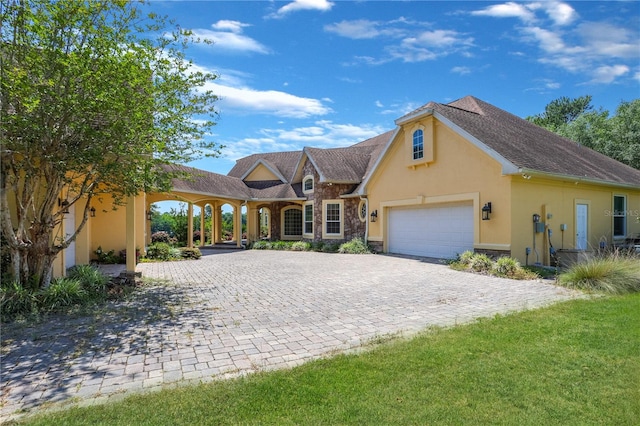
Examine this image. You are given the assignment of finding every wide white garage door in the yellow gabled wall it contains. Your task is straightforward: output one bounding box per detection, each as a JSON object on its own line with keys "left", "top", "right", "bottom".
{"left": 387, "top": 203, "right": 473, "bottom": 259}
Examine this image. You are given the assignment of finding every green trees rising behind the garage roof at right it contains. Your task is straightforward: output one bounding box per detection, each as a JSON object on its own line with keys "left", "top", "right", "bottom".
{"left": 527, "top": 95, "right": 640, "bottom": 169}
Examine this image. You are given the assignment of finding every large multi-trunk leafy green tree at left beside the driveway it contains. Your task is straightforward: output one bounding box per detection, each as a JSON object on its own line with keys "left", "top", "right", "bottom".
{"left": 0, "top": 0, "right": 220, "bottom": 287}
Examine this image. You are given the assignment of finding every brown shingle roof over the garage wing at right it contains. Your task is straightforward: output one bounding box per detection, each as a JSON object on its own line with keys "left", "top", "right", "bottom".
{"left": 397, "top": 96, "right": 640, "bottom": 186}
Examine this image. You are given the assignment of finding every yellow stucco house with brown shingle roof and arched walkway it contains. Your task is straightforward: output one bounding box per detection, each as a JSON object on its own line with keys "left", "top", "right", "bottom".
{"left": 57, "top": 96, "right": 640, "bottom": 271}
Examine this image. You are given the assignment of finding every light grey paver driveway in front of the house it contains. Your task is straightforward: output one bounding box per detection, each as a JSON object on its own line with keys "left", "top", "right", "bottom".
{"left": 1, "top": 250, "right": 577, "bottom": 418}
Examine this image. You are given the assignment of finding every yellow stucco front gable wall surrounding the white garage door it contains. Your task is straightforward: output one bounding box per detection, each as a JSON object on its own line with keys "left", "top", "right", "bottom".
{"left": 367, "top": 118, "right": 511, "bottom": 250}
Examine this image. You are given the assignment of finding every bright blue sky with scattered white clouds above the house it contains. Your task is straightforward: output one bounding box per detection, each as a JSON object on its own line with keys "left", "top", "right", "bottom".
{"left": 149, "top": 0, "right": 640, "bottom": 174}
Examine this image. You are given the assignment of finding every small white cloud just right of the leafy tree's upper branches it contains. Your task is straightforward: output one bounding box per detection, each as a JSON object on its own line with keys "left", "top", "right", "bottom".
{"left": 193, "top": 20, "right": 270, "bottom": 54}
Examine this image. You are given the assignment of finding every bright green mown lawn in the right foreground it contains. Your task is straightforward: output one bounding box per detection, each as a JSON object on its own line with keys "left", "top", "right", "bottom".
{"left": 21, "top": 294, "right": 640, "bottom": 425}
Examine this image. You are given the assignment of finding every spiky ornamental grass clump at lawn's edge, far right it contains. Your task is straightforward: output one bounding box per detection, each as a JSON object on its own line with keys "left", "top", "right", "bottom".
{"left": 558, "top": 254, "right": 640, "bottom": 294}
